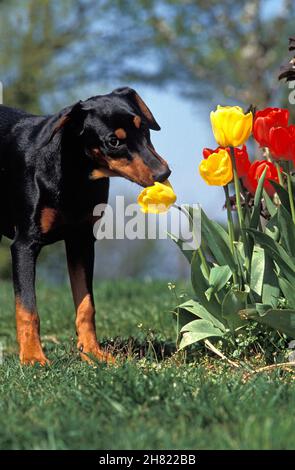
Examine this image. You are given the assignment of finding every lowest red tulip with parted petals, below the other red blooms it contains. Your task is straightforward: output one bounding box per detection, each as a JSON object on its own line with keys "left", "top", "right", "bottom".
{"left": 243, "top": 160, "right": 282, "bottom": 196}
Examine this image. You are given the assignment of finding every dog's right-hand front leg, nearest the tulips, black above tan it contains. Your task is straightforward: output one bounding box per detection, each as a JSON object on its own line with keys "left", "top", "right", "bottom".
{"left": 65, "top": 226, "right": 114, "bottom": 363}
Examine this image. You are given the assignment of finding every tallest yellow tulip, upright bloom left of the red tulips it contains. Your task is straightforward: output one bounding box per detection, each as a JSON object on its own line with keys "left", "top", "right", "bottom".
{"left": 210, "top": 105, "right": 253, "bottom": 147}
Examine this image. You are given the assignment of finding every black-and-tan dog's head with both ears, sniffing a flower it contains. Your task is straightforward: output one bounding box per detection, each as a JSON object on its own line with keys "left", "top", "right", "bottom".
{"left": 41, "top": 88, "right": 171, "bottom": 186}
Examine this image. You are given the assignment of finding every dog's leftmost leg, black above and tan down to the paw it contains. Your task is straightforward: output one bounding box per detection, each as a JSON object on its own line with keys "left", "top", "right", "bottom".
{"left": 11, "top": 238, "right": 49, "bottom": 365}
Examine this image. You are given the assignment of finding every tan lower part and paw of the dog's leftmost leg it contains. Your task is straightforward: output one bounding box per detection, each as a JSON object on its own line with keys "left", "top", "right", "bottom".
{"left": 16, "top": 299, "right": 49, "bottom": 366}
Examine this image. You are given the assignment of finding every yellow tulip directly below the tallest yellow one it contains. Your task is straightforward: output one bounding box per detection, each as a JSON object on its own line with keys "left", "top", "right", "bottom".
{"left": 199, "top": 149, "right": 233, "bottom": 186}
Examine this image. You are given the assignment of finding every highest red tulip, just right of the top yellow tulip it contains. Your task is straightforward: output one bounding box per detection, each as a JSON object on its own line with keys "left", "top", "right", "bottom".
{"left": 253, "top": 108, "right": 289, "bottom": 147}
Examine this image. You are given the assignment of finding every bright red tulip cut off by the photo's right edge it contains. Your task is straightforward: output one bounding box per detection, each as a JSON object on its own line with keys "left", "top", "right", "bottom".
{"left": 269, "top": 125, "right": 295, "bottom": 161}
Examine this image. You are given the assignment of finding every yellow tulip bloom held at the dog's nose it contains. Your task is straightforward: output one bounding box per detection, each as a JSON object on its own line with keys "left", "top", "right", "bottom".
{"left": 137, "top": 180, "right": 176, "bottom": 214}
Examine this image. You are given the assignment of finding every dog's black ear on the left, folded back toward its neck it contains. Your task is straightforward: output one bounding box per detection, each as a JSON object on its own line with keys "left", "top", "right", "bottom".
{"left": 40, "top": 101, "right": 90, "bottom": 147}
